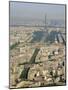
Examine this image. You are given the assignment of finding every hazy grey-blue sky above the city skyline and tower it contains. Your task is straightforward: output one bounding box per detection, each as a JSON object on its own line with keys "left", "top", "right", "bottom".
{"left": 10, "top": 2, "right": 65, "bottom": 24}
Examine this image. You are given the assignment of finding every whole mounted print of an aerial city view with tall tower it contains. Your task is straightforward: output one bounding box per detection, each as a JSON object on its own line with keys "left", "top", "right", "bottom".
{"left": 9, "top": 1, "right": 66, "bottom": 88}
